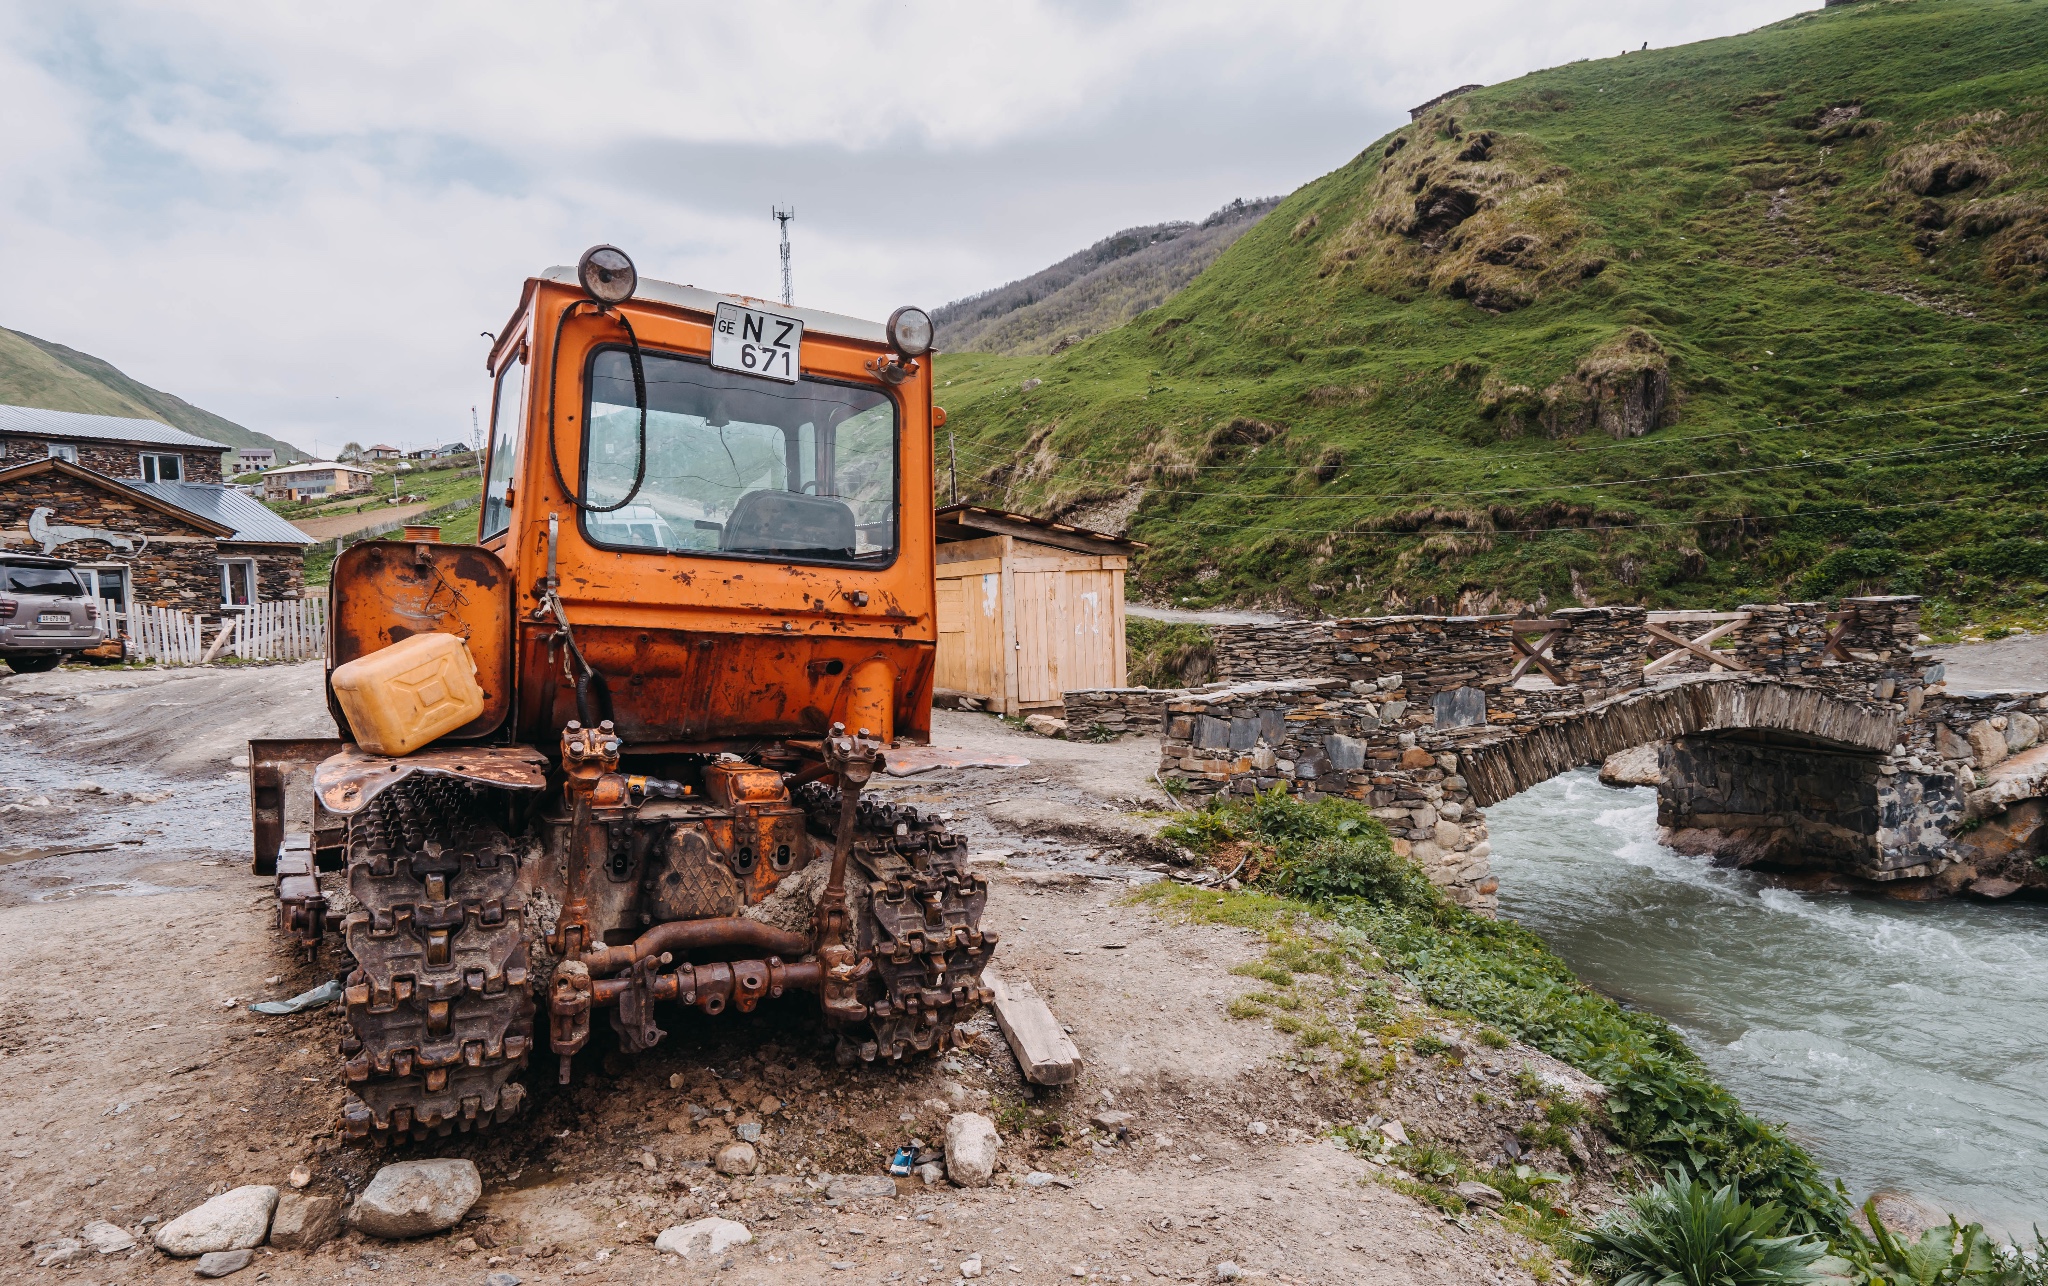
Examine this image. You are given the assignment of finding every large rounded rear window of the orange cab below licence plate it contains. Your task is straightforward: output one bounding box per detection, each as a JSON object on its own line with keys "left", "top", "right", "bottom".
{"left": 582, "top": 348, "right": 897, "bottom": 565}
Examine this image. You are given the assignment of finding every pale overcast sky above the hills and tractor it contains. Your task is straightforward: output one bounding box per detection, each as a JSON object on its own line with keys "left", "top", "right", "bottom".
{"left": 0, "top": 0, "right": 1817, "bottom": 453}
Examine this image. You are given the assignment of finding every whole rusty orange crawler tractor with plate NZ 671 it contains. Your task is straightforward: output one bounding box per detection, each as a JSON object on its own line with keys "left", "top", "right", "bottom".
{"left": 250, "top": 246, "right": 995, "bottom": 1139}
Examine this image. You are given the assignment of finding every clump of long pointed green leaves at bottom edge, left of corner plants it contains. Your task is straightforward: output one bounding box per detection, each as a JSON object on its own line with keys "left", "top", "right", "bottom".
{"left": 1585, "top": 1175, "right": 1847, "bottom": 1286}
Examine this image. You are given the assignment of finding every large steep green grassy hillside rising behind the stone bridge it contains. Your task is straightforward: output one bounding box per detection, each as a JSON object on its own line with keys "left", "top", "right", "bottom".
{"left": 938, "top": 0, "right": 2048, "bottom": 629}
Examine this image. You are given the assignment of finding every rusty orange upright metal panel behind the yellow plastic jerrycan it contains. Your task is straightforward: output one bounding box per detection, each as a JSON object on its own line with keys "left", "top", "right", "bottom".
{"left": 328, "top": 541, "right": 514, "bottom": 739}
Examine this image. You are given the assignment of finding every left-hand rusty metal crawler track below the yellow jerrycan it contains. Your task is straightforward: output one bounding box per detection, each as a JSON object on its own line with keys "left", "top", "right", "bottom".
{"left": 342, "top": 776, "right": 532, "bottom": 1141}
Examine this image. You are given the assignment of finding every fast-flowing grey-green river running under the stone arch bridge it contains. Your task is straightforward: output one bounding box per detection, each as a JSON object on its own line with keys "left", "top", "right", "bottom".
{"left": 1487, "top": 768, "right": 2048, "bottom": 1237}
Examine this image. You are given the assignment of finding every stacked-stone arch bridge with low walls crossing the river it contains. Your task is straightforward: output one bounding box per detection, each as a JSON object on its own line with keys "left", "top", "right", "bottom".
{"left": 1067, "top": 598, "right": 2048, "bottom": 909}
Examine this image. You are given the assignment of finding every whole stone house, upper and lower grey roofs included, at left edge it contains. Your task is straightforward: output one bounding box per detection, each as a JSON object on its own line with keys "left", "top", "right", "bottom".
{"left": 0, "top": 405, "right": 313, "bottom": 616}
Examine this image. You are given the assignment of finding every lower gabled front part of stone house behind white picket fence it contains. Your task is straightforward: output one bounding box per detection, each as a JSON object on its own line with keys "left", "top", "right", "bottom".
{"left": 0, "top": 442, "right": 313, "bottom": 618}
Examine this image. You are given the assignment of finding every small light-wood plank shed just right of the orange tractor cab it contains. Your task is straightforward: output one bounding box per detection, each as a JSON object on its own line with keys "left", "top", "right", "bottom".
{"left": 934, "top": 504, "right": 1145, "bottom": 715}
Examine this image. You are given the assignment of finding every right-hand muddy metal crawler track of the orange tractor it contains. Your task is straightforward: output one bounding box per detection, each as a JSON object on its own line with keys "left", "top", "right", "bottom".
{"left": 797, "top": 782, "right": 997, "bottom": 1063}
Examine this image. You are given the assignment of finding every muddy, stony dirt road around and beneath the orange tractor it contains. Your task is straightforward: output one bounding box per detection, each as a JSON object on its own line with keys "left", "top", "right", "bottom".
{"left": 0, "top": 666, "right": 1534, "bottom": 1286}
